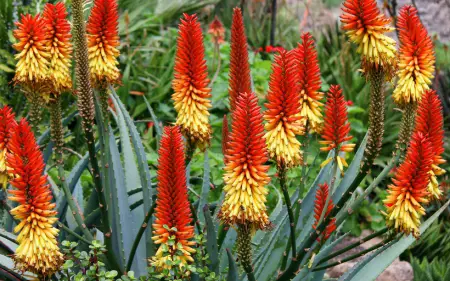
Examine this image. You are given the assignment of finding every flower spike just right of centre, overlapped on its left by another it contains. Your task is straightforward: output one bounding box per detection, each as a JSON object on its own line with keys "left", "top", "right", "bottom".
{"left": 296, "top": 33, "right": 323, "bottom": 133}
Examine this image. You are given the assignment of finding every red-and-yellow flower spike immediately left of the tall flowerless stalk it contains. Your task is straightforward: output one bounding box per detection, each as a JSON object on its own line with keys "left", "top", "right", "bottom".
{"left": 43, "top": 2, "right": 72, "bottom": 97}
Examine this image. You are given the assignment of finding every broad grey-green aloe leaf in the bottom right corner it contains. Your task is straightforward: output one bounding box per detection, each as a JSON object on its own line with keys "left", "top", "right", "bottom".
{"left": 339, "top": 200, "right": 450, "bottom": 281}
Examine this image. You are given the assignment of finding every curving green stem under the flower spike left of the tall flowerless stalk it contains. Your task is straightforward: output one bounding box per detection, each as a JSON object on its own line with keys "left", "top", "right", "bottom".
{"left": 50, "top": 97, "right": 94, "bottom": 241}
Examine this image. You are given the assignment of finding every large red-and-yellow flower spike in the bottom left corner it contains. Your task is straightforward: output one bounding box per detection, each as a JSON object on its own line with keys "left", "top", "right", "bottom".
{"left": 7, "top": 119, "right": 63, "bottom": 276}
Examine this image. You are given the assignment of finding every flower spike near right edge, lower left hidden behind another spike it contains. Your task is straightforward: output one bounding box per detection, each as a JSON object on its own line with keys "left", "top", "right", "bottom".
{"left": 416, "top": 90, "right": 446, "bottom": 199}
